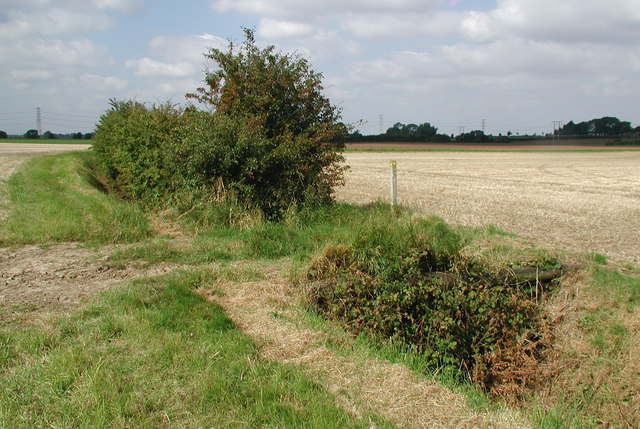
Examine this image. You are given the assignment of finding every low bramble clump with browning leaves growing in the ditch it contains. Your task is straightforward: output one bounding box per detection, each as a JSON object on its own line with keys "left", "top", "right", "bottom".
{"left": 308, "top": 218, "right": 561, "bottom": 398}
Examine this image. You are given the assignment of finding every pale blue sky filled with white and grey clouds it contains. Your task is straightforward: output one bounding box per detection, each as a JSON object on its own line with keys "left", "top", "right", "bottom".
{"left": 0, "top": 0, "right": 640, "bottom": 134}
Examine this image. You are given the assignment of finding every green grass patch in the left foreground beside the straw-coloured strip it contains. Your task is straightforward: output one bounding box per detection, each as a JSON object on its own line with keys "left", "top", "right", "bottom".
{"left": 0, "top": 270, "right": 386, "bottom": 428}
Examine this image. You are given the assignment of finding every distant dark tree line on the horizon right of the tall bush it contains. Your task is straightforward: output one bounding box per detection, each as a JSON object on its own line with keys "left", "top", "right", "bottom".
{"left": 347, "top": 116, "right": 640, "bottom": 143}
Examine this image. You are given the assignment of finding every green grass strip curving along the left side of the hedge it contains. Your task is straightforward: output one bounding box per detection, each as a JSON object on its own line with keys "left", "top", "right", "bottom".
{"left": 0, "top": 153, "right": 149, "bottom": 245}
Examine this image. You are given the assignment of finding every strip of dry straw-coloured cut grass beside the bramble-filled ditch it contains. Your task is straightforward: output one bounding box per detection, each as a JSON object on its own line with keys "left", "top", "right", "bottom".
{"left": 207, "top": 267, "right": 528, "bottom": 428}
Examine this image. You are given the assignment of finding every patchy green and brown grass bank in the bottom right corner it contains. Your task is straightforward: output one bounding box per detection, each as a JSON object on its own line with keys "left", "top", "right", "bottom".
{"left": 534, "top": 264, "right": 640, "bottom": 428}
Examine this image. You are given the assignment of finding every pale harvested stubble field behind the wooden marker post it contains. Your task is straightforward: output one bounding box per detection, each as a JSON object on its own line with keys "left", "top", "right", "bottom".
{"left": 337, "top": 151, "right": 640, "bottom": 264}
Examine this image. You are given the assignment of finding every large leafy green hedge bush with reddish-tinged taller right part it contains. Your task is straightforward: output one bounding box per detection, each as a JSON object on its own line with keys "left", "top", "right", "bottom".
{"left": 94, "top": 30, "right": 347, "bottom": 219}
